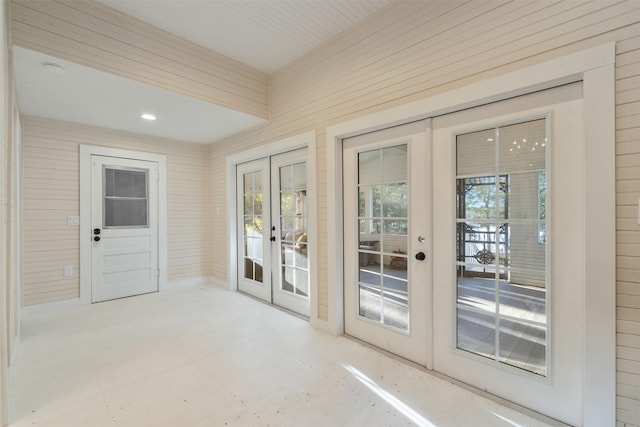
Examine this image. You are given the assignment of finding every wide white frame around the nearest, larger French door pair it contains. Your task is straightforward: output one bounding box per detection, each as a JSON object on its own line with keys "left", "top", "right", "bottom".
{"left": 328, "top": 42, "right": 616, "bottom": 426}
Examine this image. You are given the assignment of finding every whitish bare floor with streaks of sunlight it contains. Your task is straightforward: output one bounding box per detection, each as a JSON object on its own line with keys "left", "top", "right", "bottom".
{"left": 9, "top": 286, "right": 560, "bottom": 427}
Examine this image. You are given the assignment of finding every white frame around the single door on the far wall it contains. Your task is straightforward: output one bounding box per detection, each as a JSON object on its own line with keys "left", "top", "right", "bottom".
{"left": 80, "top": 144, "right": 168, "bottom": 304}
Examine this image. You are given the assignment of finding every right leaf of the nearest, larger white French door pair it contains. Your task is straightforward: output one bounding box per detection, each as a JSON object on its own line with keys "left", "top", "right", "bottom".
{"left": 433, "top": 84, "right": 584, "bottom": 425}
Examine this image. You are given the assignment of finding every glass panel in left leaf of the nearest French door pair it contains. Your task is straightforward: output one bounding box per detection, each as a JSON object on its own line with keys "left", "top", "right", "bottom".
{"left": 358, "top": 144, "right": 409, "bottom": 332}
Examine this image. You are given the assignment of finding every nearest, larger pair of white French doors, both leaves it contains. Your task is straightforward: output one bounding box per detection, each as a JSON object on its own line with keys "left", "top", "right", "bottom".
{"left": 343, "top": 83, "right": 597, "bottom": 425}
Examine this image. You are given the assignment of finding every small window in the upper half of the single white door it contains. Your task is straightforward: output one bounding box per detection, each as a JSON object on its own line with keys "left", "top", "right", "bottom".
{"left": 103, "top": 166, "right": 149, "bottom": 228}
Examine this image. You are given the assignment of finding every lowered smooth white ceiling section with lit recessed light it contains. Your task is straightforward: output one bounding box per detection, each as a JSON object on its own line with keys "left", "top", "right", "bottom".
{"left": 13, "top": 46, "right": 266, "bottom": 144}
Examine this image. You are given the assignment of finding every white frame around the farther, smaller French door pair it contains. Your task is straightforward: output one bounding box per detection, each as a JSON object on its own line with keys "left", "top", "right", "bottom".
{"left": 226, "top": 129, "right": 319, "bottom": 325}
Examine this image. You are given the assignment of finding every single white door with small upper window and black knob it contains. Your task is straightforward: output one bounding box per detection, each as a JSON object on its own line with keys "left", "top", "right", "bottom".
{"left": 90, "top": 155, "right": 159, "bottom": 302}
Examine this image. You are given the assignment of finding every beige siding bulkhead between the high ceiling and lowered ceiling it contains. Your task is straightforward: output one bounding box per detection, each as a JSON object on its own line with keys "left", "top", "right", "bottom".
{"left": 11, "top": 0, "right": 269, "bottom": 118}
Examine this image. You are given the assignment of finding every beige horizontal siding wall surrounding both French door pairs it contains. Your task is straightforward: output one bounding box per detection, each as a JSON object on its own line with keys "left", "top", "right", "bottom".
{"left": 209, "top": 0, "right": 640, "bottom": 426}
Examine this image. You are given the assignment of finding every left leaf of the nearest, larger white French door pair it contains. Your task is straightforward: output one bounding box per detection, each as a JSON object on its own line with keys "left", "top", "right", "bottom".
{"left": 343, "top": 121, "right": 432, "bottom": 366}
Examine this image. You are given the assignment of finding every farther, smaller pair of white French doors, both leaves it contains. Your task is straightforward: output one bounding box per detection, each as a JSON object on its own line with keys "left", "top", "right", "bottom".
{"left": 236, "top": 149, "right": 310, "bottom": 316}
